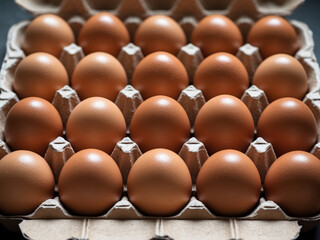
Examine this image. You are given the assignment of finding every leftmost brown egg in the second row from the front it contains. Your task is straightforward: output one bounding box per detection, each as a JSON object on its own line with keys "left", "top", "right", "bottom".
{"left": 4, "top": 97, "right": 63, "bottom": 156}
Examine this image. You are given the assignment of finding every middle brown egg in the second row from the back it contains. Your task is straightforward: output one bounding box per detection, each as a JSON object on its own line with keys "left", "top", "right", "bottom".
{"left": 132, "top": 52, "right": 189, "bottom": 99}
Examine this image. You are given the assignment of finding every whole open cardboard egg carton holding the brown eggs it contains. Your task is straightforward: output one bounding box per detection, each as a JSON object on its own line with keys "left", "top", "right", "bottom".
{"left": 0, "top": 0, "right": 320, "bottom": 240}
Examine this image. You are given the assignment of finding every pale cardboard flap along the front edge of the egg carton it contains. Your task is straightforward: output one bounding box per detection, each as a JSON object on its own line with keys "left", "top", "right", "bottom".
{"left": 19, "top": 219, "right": 300, "bottom": 240}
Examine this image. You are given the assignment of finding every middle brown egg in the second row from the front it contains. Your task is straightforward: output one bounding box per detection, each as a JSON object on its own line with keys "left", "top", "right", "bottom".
{"left": 130, "top": 96, "right": 190, "bottom": 152}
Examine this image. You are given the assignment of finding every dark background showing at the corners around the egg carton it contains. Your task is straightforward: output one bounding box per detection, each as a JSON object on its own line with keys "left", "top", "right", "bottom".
{"left": 0, "top": 0, "right": 320, "bottom": 240}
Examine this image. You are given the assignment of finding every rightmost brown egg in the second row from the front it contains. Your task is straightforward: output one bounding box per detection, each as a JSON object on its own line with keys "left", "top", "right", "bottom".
{"left": 257, "top": 98, "right": 318, "bottom": 156}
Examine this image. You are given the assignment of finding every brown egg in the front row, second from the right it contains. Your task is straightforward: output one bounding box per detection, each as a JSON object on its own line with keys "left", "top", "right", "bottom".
{"left": 196, "top": 149, "right": 261, "bottom": 217}
